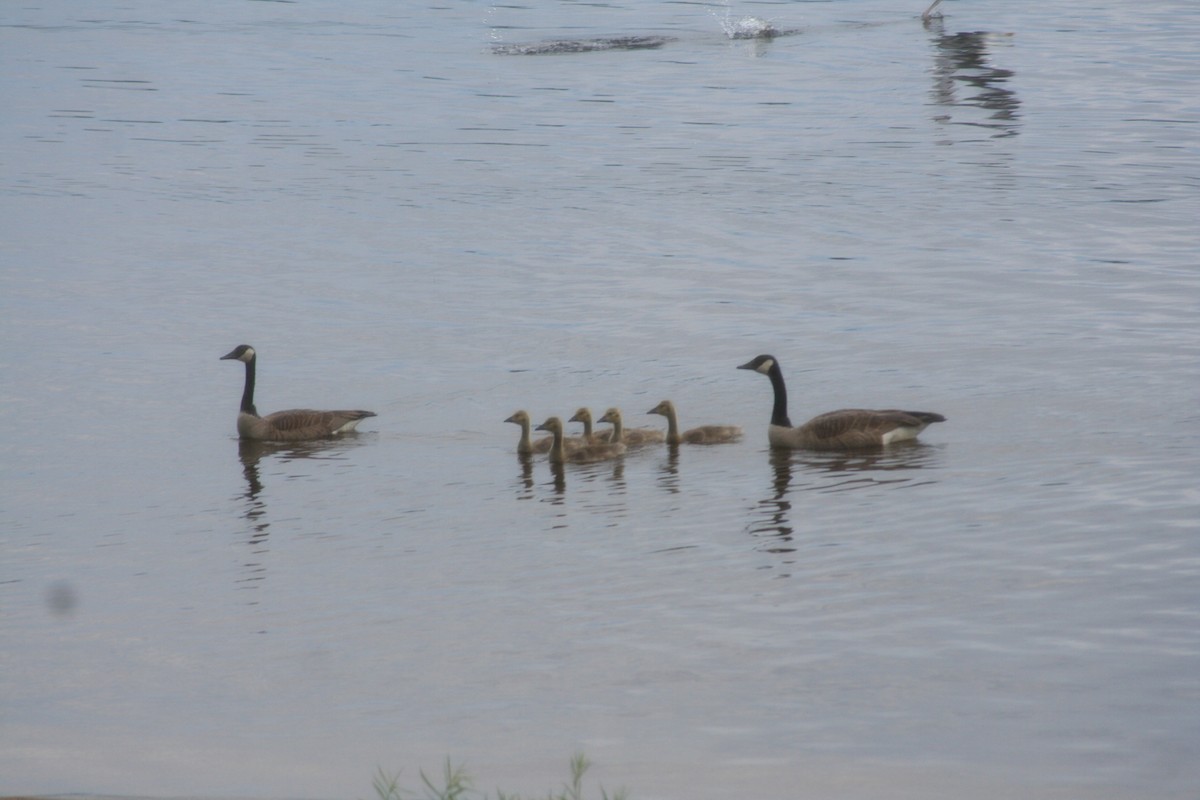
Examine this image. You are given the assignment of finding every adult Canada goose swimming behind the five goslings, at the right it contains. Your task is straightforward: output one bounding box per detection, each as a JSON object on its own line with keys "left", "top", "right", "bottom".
{"left": 738, "top": 355, "right": 946, "bottom": 450}
